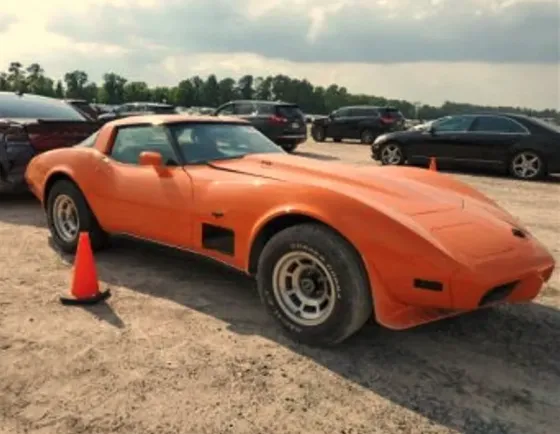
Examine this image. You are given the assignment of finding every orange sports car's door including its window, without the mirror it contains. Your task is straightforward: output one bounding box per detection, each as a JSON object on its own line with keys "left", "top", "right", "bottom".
{"left": 93, "top": 125, "right": 192, "bottom": 248}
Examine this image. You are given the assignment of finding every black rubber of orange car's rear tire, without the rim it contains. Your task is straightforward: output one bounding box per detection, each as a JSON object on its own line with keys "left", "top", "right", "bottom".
{"left": 47, "top": 180, "right": 109, "bottom": 254}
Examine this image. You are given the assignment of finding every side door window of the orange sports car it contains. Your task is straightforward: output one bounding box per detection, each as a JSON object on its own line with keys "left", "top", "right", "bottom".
{"left": 110, "top": 125, "right": 179, "bottom": 166}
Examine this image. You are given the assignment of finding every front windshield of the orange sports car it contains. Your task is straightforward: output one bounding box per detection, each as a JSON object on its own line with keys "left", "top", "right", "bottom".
{"left": 169, "top": 122, "right": 286, "bottom": 164}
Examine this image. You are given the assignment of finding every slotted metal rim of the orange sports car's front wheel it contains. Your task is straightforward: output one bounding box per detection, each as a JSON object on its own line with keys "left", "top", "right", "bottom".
{"left": 272, "top": 251, "right": 336, "bottom": 327}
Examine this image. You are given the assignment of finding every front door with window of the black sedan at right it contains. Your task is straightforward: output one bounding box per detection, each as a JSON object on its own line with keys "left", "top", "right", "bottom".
{"left": 408, "top": 115, "right": 474, "bottom": 162}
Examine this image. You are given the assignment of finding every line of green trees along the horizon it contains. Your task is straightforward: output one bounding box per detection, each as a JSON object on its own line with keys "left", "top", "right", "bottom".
{"left": 0, "top": 62, "right": 560, "bottom": 122}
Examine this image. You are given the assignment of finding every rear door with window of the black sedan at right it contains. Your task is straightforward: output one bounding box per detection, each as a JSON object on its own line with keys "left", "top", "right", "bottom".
{"left": 459, "top": 115, "right": 530, "bottom": 166}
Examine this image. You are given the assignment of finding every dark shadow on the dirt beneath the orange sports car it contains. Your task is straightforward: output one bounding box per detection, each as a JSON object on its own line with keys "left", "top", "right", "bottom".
{"left": 49, "top": 239, "right": 560, "bottom": 434}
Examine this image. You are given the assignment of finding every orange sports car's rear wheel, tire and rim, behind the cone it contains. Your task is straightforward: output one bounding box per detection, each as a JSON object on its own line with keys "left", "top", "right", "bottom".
{"left": 47, "top": 180, "right": 108, "bottom": 253}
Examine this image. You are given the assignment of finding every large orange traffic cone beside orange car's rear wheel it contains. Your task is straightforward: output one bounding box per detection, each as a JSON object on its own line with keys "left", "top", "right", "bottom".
{"left": 60, "top": 232, "right": 111, "bottom": 305}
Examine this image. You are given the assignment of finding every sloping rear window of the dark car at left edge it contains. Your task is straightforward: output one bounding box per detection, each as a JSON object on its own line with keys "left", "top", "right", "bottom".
{"left": 0, "top": 94, "right": 89, "bottom": 121}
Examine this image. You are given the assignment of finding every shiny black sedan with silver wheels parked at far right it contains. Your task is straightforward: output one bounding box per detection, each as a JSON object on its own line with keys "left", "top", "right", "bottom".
{"left": 371, "top": 113, "right": 560, "bottom": 179}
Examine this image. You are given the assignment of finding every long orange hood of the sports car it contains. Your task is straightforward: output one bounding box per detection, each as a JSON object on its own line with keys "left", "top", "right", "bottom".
{"left": 213, "top": 154, "right": 508, "bottom": 216}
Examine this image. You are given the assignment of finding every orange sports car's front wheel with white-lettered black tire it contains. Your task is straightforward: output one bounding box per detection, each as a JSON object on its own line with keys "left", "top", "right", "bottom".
{"left": 257, "top": 224, "right": 373, "bottom": 345}
